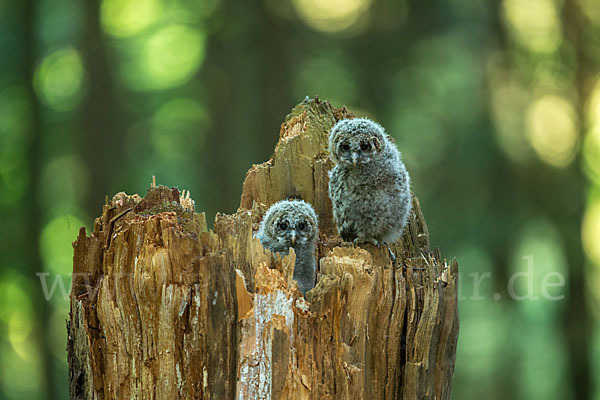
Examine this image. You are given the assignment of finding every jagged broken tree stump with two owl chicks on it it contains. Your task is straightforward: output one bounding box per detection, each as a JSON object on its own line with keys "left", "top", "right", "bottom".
{"left": 68, "top": 100, "right": 458, "bottom": 399}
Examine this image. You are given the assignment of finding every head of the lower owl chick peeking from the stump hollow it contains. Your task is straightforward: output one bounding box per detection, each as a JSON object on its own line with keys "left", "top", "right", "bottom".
{"left": 261, "top": 200, "right": 319, "bottom": 251}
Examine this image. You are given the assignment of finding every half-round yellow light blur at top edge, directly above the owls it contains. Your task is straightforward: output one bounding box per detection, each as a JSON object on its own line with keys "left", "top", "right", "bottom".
{"left": 292, "top": 0, "right": 372, "bottom": 33}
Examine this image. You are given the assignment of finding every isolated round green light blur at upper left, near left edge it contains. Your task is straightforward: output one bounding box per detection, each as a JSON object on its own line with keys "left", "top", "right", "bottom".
{"left": 34, "top": 47, "right": 84, "bottom": 111}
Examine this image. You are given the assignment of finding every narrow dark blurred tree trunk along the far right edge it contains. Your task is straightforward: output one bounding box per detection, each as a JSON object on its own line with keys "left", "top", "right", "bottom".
{"left": 552, "top": 0, "right": 598, "bottom": 400}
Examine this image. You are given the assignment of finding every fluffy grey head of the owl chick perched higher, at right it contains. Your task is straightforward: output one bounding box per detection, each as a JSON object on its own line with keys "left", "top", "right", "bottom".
{"left": 329, "top": 118, "right": 386, "bottom": 167}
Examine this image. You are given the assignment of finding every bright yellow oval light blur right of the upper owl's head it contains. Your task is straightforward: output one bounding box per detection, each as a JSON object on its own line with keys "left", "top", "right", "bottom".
{"left": 526, "top": 95, "right": 578, "bottom": 167}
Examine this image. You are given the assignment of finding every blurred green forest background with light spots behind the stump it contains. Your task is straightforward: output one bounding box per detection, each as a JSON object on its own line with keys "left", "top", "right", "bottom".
{"left": 0, "top": 0, "right": 600, "bottom": 399}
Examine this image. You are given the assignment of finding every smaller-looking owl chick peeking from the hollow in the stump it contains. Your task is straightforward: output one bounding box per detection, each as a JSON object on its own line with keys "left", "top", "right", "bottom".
{"left": 256, "top": 200, "right": 319, "bottom": 294}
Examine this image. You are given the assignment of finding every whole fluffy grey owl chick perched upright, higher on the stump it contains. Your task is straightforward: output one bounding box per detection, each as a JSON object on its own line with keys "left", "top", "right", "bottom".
{"left": 329, "top": 118, "right": 412, "bottom": 245}
